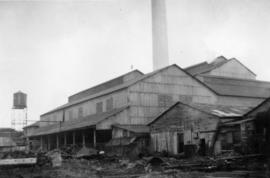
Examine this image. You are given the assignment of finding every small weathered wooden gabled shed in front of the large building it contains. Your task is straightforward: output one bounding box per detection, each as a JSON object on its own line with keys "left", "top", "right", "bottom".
{"left": 148, "top": 102, "right": 250, "bottom": 156}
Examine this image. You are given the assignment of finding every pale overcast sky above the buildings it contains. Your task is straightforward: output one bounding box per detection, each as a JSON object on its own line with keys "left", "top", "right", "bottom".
{"left": 0, "top": 0, "right": 270, "bottom": 127}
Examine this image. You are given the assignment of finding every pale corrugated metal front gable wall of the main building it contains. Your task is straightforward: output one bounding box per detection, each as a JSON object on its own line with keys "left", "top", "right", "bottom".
{"left": 129, "top": 66, "right": 216, "bottom": 124}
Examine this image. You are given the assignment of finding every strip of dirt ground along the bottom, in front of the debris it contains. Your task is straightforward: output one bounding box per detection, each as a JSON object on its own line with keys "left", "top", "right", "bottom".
{"left": 0, "top": 160, "right": 268, "bottom": 178}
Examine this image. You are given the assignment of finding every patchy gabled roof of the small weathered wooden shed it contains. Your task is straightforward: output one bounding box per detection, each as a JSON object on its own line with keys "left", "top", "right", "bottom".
{"left": 147, "top": 101, "right": 252, "bottom": 125}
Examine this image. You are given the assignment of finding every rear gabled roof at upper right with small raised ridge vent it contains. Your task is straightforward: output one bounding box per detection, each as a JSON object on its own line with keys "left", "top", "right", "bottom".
{"left": 185, "top": 56, "right": 256, "bottom": 76}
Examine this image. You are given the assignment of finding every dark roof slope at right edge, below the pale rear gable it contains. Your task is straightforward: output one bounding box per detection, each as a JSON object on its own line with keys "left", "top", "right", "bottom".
{"left": 200, "top": 75, "right": 270, "bottom": 98}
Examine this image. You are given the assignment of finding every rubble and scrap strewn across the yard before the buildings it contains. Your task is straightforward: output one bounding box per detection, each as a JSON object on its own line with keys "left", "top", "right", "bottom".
{"left": 33, "top": 147, "right": 267, "bottom": 175}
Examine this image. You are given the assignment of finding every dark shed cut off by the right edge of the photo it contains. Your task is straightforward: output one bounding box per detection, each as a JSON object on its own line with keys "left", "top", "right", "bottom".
{"left": 218, "top": 98, "right": 270, "bottom": 154}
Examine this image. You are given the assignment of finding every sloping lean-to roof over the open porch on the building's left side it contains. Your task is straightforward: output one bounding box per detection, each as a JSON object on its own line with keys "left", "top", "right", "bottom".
{"left": 30, "top": 106, "right": 127, "bottom": 137}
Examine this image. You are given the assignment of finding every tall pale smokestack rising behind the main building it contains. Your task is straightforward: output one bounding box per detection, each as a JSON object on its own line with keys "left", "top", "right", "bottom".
{"left": 151, "top": 0, "right": 169, "bottom": 70}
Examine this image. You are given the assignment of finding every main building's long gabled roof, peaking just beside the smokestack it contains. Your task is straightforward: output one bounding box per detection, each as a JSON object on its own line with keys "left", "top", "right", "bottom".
{"left": 41, "top": 64, "right": 217, "bottom": 116}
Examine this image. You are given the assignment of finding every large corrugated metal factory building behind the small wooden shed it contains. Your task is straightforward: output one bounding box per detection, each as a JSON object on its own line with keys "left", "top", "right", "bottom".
{"left": 25, "top": 56, "right": 270, "bottom": 156}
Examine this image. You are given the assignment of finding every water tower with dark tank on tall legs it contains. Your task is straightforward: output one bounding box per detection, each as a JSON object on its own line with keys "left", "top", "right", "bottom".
{"left": 11, "top": 91, "right": 27, "bottom": 130}
